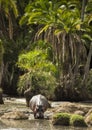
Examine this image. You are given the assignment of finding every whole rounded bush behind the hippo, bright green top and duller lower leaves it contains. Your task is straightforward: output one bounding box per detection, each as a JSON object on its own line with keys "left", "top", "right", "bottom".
{"left": 17, "top": 42, "right": 57, "bottom": 97}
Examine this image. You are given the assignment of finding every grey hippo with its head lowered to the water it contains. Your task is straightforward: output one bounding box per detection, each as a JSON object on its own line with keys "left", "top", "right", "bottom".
{"left": 29, "top": 94, "right": 50, "bottom": 119}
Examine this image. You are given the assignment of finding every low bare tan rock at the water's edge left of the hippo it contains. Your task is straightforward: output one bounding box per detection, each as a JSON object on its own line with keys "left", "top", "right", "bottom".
{"left": 1, "top": 111, "right": 28, "bottom": 120}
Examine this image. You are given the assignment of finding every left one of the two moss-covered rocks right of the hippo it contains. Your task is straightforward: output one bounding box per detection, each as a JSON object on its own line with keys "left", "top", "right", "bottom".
{"left": 52, "top": 113, "right": 70, "bottom": 126}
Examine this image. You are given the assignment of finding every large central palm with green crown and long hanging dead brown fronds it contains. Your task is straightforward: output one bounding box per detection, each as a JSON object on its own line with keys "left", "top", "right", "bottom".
{"left": 20, "top": 0, "right": 91, "bottom": 100}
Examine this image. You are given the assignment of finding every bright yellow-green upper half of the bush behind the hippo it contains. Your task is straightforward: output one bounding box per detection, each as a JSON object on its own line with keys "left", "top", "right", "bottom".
{"left": 17, "top": 41, "right": 57, "bottom": 74}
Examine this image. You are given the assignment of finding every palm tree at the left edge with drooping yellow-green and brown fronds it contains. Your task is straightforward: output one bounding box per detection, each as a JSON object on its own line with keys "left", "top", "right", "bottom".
{"left": 0, "top": 0, "right": 18, "bottom": 96}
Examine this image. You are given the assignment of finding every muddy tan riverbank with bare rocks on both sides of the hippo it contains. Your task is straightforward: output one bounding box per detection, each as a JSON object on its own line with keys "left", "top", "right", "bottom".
{"left": 0, "top": 97, "right": 92, "bottom": 130}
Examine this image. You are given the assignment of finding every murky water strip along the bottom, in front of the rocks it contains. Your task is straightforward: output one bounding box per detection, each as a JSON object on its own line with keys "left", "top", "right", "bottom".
{"left": 0, "top": 120, "right": 92, "bottom": 130}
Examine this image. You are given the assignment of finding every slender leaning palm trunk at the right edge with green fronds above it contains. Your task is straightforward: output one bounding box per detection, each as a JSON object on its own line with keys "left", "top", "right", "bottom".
{"left": 81, "top": 0, "right": 92, "bottom": 84}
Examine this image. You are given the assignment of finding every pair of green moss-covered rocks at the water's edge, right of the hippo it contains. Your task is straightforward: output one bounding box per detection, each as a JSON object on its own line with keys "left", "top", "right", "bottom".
{"left": 52, "top": 113, "right": 87, "bottom": 127}
